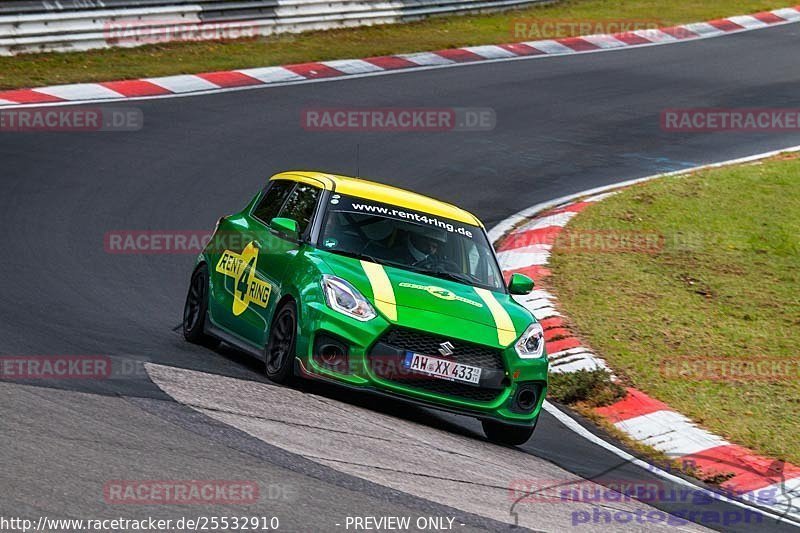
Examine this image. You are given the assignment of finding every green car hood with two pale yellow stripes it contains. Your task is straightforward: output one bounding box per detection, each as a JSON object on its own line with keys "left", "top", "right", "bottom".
{"left": 318, "top": 253, "right": 532, "bottom": 346}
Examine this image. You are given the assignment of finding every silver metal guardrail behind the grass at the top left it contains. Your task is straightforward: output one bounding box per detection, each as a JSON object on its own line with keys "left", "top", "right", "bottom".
{"left": 0, "top": 0, "right": 552, "bottom": 55}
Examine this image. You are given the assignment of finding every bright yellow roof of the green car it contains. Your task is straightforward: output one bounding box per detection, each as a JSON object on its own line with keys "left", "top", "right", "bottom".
{"left": 271, "top": 171, "right": 483, "bottom": 227}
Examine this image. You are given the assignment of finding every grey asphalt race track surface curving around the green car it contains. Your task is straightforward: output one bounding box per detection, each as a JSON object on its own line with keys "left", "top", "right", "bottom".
{"left": 0, "top": 20, "right": 800, "bottom": 531}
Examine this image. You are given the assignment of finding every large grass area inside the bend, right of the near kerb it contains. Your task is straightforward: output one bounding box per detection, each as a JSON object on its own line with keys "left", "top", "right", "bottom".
{"left": 552, "top": 156, "right": 800, "bottom": 464}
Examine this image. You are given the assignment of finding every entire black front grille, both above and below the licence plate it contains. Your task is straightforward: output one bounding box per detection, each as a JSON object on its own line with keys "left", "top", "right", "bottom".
{"left": 369, "top": 328, "right": 505, "bottom": 403}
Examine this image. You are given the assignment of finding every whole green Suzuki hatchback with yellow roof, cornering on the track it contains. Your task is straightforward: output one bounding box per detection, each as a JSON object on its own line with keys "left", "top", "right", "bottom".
{"left": 183, "top": 172, "right": 548, "bottom": 445}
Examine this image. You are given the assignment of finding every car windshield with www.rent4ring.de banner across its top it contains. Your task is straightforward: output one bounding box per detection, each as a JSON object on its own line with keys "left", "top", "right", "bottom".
{"left": 318, "top": 194, "right": 504, "bottom": 292}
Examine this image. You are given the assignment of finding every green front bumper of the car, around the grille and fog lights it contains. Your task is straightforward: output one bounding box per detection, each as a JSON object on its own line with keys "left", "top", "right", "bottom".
{"left": 297, "top": 303, "right": 548, "bottom": 425}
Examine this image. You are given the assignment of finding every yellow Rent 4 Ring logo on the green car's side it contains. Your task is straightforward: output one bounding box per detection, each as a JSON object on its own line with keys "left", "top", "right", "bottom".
{"left": 216, "top": 242, "right": 272, "bottom": 316}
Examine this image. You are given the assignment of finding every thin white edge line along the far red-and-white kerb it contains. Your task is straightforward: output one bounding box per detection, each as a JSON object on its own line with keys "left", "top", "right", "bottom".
{"left": 0, "top": 18, "right": 800, "bottom": 111}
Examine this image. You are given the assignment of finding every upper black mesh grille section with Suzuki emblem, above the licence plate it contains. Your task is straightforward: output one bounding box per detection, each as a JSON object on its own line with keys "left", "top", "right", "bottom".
{"left": 380, "top": 328, "right": 504, "bottom": 370}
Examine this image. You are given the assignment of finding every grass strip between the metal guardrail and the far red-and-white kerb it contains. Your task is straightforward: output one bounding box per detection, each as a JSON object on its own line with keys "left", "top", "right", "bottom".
{"left": 0, "top": 0, "right": 787, "bottom": 89}
